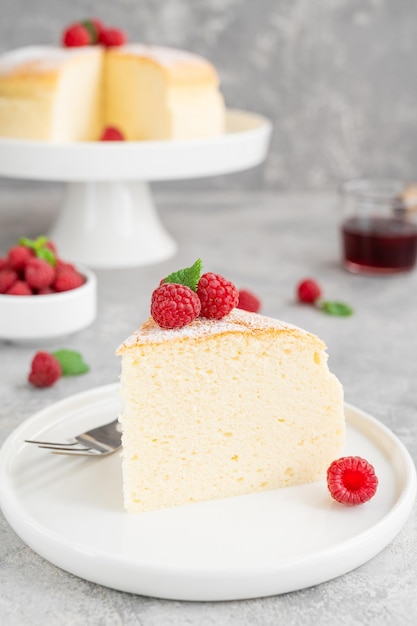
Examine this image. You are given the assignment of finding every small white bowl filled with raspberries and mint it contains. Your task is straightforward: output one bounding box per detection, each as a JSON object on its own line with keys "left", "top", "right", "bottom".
{"left": 0, "top": 237, "right": 97, "bottom": 342}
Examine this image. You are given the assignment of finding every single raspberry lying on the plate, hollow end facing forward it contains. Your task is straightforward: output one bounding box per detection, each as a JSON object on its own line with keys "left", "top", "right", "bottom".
{"left": 327, "top": 456, "right": 378, "bottom": 505}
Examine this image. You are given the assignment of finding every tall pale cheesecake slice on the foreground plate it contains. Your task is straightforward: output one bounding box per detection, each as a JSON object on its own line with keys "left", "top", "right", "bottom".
{"left": 117, "top": 309, "right": 344, "bottom": 512}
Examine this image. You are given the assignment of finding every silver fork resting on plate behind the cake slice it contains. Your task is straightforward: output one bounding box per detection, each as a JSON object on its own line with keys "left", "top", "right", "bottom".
{"left": 25, "top": 419, "right": 122, "bottom": 456}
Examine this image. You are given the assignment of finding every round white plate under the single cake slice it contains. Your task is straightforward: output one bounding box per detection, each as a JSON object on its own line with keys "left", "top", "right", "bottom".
{"left": 0, "top": 385, "right": 416, "bottom": 601}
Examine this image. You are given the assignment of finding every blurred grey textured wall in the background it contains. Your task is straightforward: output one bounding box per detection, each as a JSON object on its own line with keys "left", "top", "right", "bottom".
{"left": 0, "top": 0, "right": 417, "bottom": 190}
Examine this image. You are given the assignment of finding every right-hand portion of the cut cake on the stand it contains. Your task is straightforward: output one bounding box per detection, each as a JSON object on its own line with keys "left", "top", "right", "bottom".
{"left": 105, "top": 44, "right": 225, "bottom": 141}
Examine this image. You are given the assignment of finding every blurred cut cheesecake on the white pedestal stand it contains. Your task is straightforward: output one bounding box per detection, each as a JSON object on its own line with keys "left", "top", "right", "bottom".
{"left": 0, "top": 44, "right": 225, "bottom": 142}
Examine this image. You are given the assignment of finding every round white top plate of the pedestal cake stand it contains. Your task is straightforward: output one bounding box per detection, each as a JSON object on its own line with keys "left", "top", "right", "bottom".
{"left": 0, "top": 109, "right": 272, "bottom": 182}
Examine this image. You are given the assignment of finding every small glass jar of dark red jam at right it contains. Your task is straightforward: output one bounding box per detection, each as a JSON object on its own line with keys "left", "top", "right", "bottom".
{"left": 341, "top": 179, "right": 417, "bottom": 274}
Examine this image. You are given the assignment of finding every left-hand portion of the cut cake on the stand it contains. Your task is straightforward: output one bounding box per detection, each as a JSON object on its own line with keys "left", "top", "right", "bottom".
{"left": 0, "top": 46, "right": 104, "bottom": 142}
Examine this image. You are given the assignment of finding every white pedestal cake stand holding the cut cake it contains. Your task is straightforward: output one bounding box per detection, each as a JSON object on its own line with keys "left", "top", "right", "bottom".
{"left": 0, "top": 110, "right": 272, "bottom": 268}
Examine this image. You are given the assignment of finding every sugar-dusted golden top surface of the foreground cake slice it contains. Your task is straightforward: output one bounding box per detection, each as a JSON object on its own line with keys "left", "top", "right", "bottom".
{"left": 116, "top": 308, "right": 324, "bottom": 354}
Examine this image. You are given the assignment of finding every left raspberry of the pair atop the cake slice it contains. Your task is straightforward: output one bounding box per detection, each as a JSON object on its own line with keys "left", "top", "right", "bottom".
{"left": 151, "top": 283, "right": 201, "bottom": 328}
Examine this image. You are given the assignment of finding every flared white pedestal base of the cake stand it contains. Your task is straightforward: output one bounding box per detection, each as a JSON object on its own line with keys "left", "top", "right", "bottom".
{"left": 48, "top": 181, "right": 177, "bottom": 268}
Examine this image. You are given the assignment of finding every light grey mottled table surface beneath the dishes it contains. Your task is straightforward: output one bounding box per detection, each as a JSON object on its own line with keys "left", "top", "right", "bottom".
{"left": 0, "top": 185, "right": 417, "bottom": 626}
